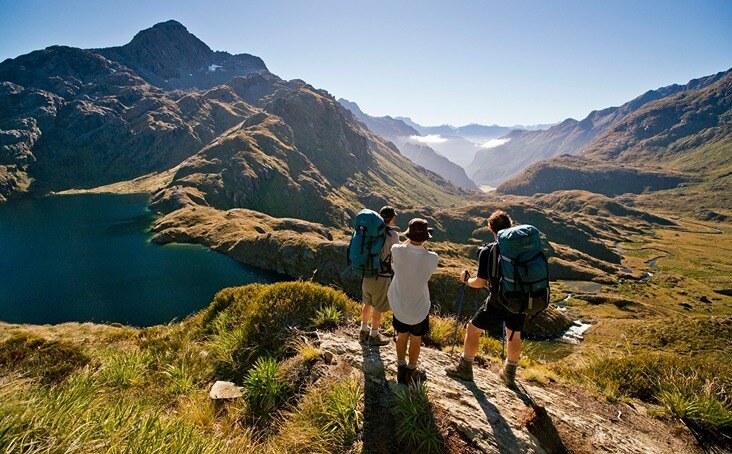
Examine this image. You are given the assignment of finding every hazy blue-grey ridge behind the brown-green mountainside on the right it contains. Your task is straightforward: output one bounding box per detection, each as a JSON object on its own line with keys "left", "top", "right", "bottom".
{"left": 467, "top": 68, "right": 727, "bottom": 186}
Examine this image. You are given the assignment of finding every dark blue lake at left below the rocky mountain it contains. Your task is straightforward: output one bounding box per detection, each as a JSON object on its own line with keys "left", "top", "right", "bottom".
{"left": 0, "top": 194, "right": 278, "bottom": 326}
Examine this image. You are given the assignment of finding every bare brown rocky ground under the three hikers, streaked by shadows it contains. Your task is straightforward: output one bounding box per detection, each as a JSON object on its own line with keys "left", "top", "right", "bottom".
{"left": 321, "top": 332, "right": 700, "bottom": 453}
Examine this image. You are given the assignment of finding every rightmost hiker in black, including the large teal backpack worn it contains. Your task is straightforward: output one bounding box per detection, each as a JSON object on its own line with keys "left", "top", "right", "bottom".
{"left": 445, "top": 210, "right": 549, "bottom": 388}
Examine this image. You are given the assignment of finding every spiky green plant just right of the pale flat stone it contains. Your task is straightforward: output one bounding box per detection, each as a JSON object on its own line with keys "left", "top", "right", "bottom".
{"left": 243, "top": 357, "right": 290, "bottom": 419}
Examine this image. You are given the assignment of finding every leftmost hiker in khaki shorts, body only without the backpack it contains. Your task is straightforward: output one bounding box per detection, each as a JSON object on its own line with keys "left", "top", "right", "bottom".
{"left": 359, "top": 205, "right": 399, "bottom": 346}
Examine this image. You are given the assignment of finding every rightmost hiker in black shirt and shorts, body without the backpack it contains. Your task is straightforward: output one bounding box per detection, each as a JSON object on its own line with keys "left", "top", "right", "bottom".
{"left": 445, "top": 210, "right": 526, "bottom": 388}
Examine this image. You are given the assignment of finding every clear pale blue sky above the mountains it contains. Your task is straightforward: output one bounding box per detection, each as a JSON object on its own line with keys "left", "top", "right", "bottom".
{"left": 0, "top": 0, "right": 732, "bottom": 125}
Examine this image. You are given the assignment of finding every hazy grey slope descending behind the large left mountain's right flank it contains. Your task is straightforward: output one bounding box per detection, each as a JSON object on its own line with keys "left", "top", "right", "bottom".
{"left": 338, "top": 98, "right": 479, "bottom": 191}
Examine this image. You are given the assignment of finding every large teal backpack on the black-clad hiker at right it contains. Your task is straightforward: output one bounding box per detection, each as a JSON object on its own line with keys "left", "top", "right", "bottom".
{"left": 491, "top": 225, "right": 549, "bottom": 318}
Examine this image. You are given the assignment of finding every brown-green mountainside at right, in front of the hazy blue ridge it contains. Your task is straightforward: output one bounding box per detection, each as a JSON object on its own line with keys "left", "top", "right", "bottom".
{"left": 498, "top": 70, "right": 732, "bottom": 209}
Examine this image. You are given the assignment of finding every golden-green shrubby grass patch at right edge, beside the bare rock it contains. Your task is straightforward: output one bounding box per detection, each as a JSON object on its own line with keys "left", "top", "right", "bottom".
{"left": 562, "top": 353, "right": 732, "bottom": 431}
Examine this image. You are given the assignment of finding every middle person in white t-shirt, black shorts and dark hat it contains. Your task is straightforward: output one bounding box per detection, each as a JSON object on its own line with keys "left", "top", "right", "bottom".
{"left": 388, "top": 218, "right": 439, "bottom": 384}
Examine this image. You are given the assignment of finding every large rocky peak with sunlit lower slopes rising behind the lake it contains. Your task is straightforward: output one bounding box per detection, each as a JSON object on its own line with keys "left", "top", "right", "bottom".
{"left": 0, "top": 21, "right": 463, "bottom": 225}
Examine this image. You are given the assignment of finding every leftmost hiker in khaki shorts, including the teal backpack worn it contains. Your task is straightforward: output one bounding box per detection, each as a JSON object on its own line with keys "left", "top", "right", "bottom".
{"left": 348, "top": 206, "right": 399, "bottom": 346}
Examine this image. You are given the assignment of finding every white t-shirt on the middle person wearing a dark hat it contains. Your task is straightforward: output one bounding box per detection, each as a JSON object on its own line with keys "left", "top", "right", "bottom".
{"left": 387, "top": 242, "right": 439, "bottom": 325}
